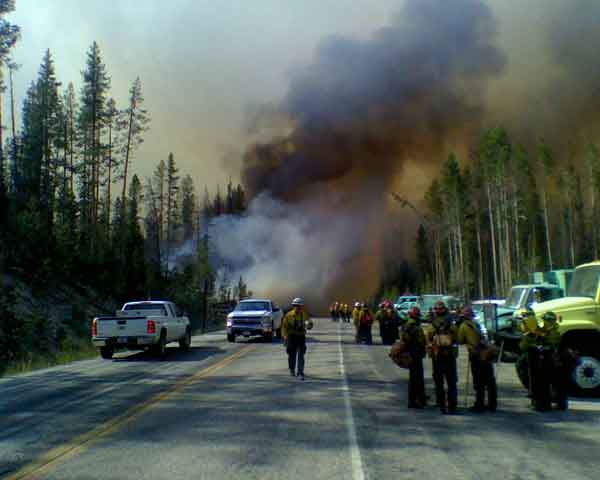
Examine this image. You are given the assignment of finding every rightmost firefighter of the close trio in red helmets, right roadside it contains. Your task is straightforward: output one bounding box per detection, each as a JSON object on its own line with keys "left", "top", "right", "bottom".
{"left": 458, "top": 305, "right": 498, "bottom": 413}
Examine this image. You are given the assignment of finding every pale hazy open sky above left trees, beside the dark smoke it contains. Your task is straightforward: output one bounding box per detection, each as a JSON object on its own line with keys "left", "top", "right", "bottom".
{"left": 5, "top": 0, "right": 401, "bottom": 189}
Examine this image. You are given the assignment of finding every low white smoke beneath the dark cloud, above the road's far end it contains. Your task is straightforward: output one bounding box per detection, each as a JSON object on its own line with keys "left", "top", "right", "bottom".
{"left": 210, "top": 193, "right": 380, "bottom": 307}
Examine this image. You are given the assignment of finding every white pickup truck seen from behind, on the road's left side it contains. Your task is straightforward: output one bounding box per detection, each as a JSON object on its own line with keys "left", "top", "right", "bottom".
{"left": 92, "top": 301, "right": 192, "bottom": 359}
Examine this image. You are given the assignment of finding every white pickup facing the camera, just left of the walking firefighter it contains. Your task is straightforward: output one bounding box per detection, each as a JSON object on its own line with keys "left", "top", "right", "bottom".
{"left": 227, "top": 299, "right": 283, "bottom": 342}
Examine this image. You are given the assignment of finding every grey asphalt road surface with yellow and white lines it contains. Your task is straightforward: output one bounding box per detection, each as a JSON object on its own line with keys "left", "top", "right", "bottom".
{"left": 0, "top": 319, "right": 600, "bottom": 480}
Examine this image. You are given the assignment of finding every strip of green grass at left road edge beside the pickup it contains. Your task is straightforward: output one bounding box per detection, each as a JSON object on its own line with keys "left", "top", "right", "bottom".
{"left": 0, "top": 341, "right": 98, "bottom": 377}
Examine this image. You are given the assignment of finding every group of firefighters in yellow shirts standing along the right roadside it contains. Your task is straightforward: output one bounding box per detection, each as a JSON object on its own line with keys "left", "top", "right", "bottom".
{"left": 330, "top": 300, "right": 572, "bottom": 414}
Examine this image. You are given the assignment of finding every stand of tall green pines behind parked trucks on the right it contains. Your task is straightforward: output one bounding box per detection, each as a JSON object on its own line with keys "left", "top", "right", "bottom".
{"left": 416, "top": 128, "right": 600, "bottom": 297}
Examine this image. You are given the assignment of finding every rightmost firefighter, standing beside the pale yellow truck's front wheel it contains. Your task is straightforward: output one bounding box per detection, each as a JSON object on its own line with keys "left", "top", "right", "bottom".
{"left": 542, "top": 312, "right": 571, "bottom": 411}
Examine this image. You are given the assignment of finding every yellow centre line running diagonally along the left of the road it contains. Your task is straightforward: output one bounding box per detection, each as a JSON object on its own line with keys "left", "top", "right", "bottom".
{"left": 4, "top": 345, "right": 256, "bottom": 480}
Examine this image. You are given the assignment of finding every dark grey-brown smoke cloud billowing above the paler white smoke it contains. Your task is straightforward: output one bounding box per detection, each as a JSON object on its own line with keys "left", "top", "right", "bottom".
{"left": 243, "top": 0, "right": 504, "bottom": 198}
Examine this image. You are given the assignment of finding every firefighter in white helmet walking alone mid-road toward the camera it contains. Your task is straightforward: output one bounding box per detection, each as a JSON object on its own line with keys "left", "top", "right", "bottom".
{"left": 281, "top": 298, "right": 313, "bottom": 380}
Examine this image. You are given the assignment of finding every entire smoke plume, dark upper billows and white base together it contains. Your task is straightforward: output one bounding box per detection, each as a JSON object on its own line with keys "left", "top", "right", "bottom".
{"left": 211, "top": 0, "right": 600, "bottom": 307}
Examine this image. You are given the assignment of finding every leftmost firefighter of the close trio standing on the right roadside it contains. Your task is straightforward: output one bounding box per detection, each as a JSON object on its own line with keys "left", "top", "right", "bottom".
{"left": 401, "top": 307, "right": 427, "bottom": 409}
